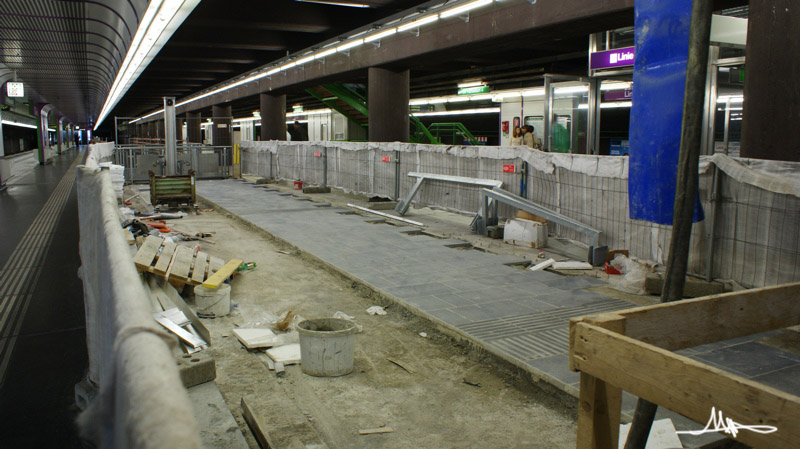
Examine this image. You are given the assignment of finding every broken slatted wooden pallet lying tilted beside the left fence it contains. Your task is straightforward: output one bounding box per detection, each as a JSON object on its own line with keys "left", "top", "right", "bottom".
{"left": 133, "top": 235, "right": 228, "bottom": 286}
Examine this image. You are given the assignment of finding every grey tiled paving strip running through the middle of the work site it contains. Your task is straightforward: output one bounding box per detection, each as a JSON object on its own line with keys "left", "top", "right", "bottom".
{"left": 198, "top": 180, "right": 800, "bottom": 447}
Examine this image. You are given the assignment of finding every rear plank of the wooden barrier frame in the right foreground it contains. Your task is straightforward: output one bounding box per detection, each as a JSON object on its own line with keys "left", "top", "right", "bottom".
{"left": 618, "top": 283, "right": 800, "bottom": 351}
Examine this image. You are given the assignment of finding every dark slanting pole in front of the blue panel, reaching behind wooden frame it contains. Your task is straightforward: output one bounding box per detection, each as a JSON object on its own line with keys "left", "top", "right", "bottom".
{"left": 625, "top": 0, "right": 713, "bottom": 449}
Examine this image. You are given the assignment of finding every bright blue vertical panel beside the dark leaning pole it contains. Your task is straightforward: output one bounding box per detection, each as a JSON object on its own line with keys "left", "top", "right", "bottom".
{"left": 628, "top": 0, "right": 703, "bottom": 225}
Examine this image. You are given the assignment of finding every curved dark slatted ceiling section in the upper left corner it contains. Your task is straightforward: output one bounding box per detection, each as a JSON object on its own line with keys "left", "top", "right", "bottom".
{"left": 0, "top": 0, "right": 149, "bottom": 126}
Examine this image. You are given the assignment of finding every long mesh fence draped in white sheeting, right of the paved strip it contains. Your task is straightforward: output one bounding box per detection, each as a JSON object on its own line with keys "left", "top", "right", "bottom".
{"left": 241, "top": 141, "right": 800, "bottom": 287}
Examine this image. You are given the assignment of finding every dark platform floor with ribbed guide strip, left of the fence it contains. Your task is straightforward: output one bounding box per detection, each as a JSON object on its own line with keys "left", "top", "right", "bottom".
{"left": 0, "top": 149, "right": 87, "bottom": 448}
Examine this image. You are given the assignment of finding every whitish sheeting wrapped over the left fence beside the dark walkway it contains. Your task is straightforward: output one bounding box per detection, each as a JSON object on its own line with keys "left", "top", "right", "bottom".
{"left": 77, "top": 157, "right": 202, "bottom": 449}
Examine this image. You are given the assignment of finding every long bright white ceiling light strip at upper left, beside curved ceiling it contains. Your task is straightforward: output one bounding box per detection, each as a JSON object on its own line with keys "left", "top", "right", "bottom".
{"left": 94, "top": 0, "right": 200, "bottom": 129}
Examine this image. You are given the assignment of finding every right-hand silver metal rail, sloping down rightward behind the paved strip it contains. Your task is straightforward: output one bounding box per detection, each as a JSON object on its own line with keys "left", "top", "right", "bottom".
{"left": 478, "top": 188, "right": 600, "bottom": 247}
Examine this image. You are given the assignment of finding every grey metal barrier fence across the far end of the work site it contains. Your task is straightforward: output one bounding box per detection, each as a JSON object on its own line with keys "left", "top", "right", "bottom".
{"left": 114, "top": 145, "right": 233, "bottom": 182}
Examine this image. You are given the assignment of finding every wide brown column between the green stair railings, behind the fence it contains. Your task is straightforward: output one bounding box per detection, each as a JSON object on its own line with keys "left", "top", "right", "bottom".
{"left": 367, "top": 67, "right": 411, "bottom": 142}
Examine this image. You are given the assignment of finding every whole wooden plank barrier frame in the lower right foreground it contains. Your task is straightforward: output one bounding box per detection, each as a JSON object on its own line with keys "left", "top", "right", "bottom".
{"left": 569, "top": 283, "right": 800, "bottom": 449}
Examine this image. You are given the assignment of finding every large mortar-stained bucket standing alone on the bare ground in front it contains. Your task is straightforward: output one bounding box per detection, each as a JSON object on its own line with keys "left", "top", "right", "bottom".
{"left": 297, "top": 318, "right": 358, "bottom": 377}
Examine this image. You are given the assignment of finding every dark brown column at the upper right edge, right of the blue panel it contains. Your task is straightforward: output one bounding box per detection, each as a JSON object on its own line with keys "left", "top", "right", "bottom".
{"left": 741, "top": 0, "right": 800, "bottom": 161}
